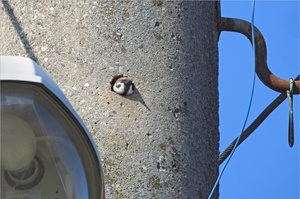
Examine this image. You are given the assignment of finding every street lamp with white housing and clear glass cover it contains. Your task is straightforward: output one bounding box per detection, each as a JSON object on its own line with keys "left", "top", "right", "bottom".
{"left": 0, "top": 56, "right": 104, "bottom": 199}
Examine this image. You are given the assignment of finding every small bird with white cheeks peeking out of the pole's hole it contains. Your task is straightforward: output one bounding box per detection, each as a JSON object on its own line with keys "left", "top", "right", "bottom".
{"left": 113, "top": 76, "right": 135, "bottom": 96}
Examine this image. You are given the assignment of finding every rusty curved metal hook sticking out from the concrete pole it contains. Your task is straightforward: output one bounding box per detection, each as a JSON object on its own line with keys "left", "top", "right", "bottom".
{"left": 220, "top": 17, "right": 300, "bottom": 94}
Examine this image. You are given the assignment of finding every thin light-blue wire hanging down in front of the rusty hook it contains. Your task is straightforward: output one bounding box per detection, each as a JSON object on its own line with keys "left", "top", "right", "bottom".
{"left": 208, "top": 0, "right": 256, "bottom": 199}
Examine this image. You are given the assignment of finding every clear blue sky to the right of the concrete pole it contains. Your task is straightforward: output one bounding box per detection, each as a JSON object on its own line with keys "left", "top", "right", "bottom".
{"left": 219, "top": 0, "right": 300, "bottom": 199}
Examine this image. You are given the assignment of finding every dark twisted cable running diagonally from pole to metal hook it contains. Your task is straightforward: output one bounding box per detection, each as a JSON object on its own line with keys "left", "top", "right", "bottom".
{"left": 219, "top": 75, "right": 300, "bottom": 165}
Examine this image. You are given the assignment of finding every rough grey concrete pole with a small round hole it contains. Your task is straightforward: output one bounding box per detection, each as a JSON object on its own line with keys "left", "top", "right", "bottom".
{"left": 0, "top": 0, "right": 219, "bottom": 199}
